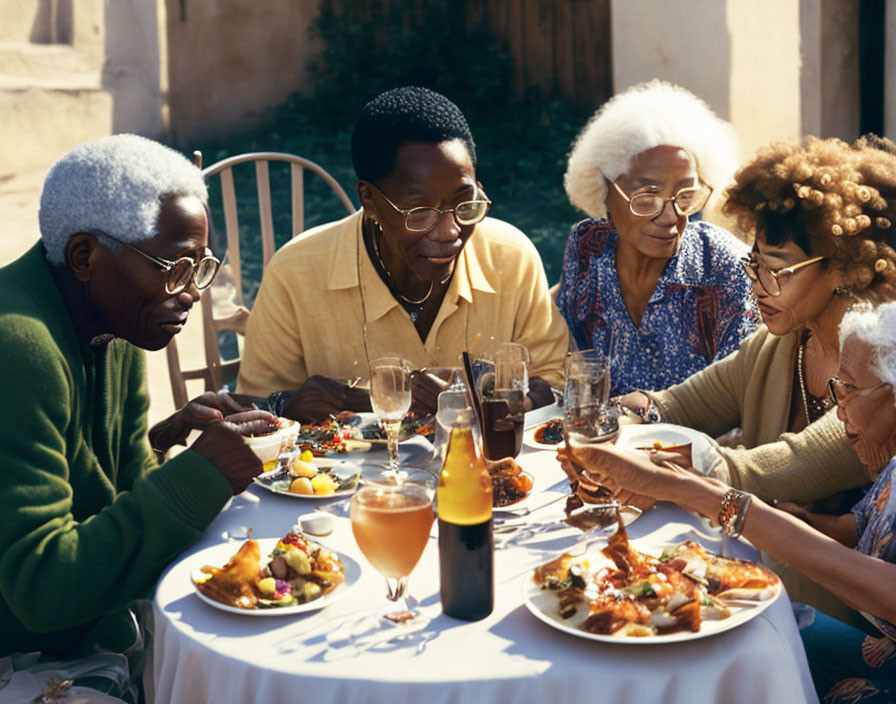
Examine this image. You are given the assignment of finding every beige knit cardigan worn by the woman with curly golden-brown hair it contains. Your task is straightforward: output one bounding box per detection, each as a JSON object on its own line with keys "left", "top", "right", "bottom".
{"left": 648, "top": 325, "right": 876, "bottom": 503}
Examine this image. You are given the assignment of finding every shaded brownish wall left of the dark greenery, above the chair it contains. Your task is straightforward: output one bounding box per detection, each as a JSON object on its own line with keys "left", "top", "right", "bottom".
{"left": 165, "top": 0, "right": 317, "bottom": 146}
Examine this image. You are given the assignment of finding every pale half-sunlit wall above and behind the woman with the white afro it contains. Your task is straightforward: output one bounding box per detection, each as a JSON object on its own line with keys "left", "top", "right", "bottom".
{"left": 611, "top": 0, "right": 801, "bottom": 165}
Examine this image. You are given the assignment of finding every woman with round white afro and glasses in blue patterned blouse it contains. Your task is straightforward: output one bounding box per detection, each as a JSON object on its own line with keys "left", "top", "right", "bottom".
{"left": 557, "top": 80, "right": 757, "bottom": 395}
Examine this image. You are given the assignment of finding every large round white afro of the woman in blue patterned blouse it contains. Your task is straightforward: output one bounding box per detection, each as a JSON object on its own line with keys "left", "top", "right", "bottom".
{"left": 563, "top": 80, "right": 740, "bottom": 219}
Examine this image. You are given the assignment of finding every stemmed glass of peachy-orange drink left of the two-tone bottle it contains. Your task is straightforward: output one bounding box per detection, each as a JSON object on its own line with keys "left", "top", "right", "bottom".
{"left": 351, "top": 469, "right": 436, "bottom": 622}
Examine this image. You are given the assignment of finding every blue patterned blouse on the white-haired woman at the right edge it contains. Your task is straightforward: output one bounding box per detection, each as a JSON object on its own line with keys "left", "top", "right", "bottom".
{"left": 852, "top": 458, "right": 896, "bottom": 639}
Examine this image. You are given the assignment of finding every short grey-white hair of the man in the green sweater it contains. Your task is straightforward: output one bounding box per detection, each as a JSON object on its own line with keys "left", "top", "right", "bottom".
{"left": 38, "top": 134, "right": 208, "bottom": 264}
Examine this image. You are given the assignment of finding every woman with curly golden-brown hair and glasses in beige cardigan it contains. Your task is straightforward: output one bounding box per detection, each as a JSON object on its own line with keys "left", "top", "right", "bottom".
{"left": 621, "top": 138, "right": 896, "bottom": 503}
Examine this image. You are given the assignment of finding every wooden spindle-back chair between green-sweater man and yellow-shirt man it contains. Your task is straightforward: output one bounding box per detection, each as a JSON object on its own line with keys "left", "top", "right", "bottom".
{"left": 166, "top": 151, "right": 355, "bottom": 408}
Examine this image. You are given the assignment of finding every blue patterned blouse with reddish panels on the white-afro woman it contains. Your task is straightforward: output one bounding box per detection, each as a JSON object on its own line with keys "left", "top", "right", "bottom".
{"left": 557, "top": 219, "right": 759, "bottom": 396}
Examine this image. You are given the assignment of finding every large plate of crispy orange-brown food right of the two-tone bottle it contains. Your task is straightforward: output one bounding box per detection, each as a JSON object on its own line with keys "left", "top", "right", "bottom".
{"left": 522, "top": 525, "right": 781, "bottom": 645}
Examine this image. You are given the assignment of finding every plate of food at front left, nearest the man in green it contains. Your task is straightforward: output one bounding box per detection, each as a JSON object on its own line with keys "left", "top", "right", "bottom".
{"left": 191, "top": 529, "right": 361, "bottom": 616}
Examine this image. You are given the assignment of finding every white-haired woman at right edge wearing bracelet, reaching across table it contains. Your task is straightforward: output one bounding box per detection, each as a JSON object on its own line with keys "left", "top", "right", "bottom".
{"left": 565, "top": 302, "right": 896, "bottom": 702}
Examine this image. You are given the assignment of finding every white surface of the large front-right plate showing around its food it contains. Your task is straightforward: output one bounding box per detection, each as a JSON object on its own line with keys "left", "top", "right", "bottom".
{"left": 521, "top": 543, "right": 781, "bottom": 645}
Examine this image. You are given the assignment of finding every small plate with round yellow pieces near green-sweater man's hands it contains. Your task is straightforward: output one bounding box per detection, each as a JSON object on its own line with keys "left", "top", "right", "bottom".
{"left": 252, "top": 450, "right": 361, "bottom": 499}
